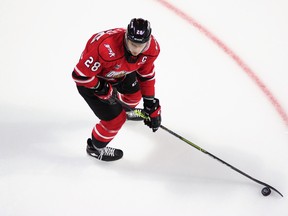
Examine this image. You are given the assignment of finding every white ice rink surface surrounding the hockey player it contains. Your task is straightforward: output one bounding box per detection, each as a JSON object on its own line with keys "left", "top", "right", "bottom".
{"left": 0, "top": 0, "right": 288, "bottom": 216}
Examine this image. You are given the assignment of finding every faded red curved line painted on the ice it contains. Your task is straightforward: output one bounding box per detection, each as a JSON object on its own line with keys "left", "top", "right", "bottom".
{"left": 155, "top": 0, "right": 288, "bottom": 126}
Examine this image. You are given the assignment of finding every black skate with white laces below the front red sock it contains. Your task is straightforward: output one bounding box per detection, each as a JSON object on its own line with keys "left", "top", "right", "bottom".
{"left": 86, "top": 138, "right": 123, "bottom": 161}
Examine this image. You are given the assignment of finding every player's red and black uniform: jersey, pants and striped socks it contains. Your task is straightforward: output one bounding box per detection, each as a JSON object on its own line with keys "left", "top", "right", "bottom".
{"left": 72, "top": 28, "right": 160, "bottom": 148}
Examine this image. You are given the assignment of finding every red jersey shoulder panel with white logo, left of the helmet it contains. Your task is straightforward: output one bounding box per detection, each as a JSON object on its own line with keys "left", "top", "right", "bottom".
{"left": 98, "top": 28, "right": 125, "bottom": 62}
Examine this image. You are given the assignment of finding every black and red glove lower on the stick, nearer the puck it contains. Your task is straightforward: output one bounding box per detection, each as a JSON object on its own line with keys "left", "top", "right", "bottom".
{"left": 143, "top": 98, "right": 161, "bottom": 132}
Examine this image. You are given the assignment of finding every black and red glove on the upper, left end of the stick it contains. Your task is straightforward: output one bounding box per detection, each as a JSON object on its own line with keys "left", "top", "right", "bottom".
{"left": 93, "top": 79, "right": 116, "bottom": 104}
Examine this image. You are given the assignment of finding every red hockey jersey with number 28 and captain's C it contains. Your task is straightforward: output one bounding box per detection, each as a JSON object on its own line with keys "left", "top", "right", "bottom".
{"left": 72, "top": 28, "right": 160, "bottom": 96}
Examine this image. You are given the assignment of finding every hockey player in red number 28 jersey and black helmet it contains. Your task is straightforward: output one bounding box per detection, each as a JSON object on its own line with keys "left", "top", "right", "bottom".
{"left": 72, "top": 18, "right": 161, "bottom": 161}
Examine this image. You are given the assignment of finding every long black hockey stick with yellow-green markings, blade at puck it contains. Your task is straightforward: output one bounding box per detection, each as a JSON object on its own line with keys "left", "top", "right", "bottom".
{"left": 116, "top": 98, "right": 283, "bottom": 197}
